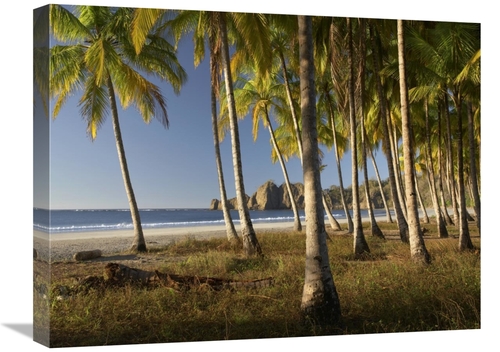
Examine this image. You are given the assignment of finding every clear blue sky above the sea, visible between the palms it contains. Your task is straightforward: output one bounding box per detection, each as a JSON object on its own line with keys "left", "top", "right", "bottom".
{"left": 35, "top": 7, "right": 387, "bottom": 209}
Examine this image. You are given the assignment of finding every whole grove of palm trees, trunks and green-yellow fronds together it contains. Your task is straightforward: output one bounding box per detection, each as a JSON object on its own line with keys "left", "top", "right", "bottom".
{"left": 42, "top": 5, "right": 481, "bottom": 323}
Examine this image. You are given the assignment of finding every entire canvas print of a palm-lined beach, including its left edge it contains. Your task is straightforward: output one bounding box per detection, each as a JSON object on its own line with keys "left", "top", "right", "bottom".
{"left": 33, "top": 4, "right": 481, "bottom": 347}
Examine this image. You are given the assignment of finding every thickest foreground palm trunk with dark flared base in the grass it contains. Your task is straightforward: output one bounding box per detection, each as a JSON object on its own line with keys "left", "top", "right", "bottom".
{"left": 298, "top": 16, "right": 341, "bottom": 325}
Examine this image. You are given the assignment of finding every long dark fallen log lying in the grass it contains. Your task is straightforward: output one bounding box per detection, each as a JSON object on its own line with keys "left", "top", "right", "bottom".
{"left": 73, "top": 263, "right": 274, "bottom": 292}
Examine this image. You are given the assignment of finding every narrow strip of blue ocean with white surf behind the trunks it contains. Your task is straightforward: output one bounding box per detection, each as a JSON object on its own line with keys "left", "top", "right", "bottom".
{"left": 33, "top": 208, "right": 392, "bottom": 233}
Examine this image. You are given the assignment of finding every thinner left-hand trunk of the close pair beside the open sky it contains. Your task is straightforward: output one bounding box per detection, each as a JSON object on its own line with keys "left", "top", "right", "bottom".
{"left": 210, "top": 48, "right": 240, "bottom": 241}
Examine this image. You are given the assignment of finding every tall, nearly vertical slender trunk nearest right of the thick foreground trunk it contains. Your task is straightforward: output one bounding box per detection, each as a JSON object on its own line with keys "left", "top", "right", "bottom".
{"left": 347, "top": 18, "right": 370, "bottom": 255}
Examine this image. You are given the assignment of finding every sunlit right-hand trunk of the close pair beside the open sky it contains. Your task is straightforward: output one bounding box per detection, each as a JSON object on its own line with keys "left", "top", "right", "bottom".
{"left": 220, "top": 13, "right": 262, "bottom": 256}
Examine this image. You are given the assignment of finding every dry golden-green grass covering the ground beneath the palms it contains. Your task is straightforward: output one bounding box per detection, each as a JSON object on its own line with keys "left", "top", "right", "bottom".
{"left": 35, "top": 223, "right": 481, "bottom": 347}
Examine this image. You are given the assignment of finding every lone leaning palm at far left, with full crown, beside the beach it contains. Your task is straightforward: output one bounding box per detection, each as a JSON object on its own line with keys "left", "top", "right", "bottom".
{"left": 50, "top": 5, "right": 186, "bottom": 251}
